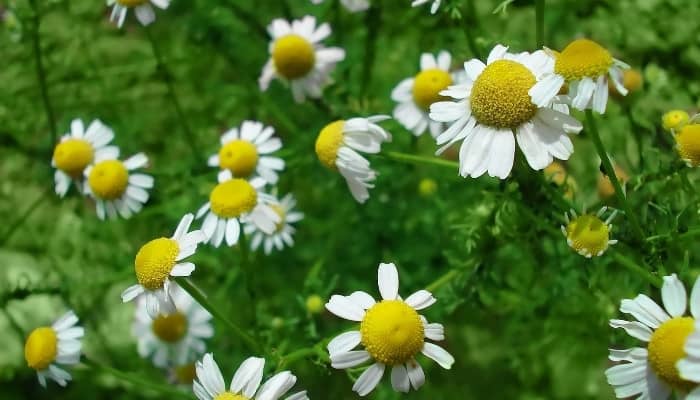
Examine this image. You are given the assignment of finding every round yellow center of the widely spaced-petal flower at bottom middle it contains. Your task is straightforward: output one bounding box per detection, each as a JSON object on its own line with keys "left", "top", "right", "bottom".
{"left": 360, "top": 300, "right": 424, "bottom": 365}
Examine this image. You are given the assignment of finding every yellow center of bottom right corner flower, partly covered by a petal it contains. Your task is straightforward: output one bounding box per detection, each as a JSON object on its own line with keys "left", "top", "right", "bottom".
{"left": 647, "top": 317, "right": 696, "bottom": 392}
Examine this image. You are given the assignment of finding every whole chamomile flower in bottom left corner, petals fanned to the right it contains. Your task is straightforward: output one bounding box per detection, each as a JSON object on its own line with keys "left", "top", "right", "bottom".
{"left": 24, "top": 311, "right": 85, "bottom": 387}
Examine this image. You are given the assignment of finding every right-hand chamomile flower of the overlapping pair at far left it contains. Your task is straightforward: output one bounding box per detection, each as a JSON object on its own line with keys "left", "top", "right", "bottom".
{"left": 84, "top": 153, "right": 153, "bottom": 219}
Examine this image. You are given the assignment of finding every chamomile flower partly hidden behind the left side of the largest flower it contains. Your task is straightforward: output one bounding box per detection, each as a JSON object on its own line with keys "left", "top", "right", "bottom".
{"left": 391, "top": 51, "right": 456, "bottom": 137}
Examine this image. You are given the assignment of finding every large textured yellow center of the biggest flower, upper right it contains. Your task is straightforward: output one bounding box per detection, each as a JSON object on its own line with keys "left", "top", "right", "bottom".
{"left": 470, "top": 60, "right": 537, "bottom": 129}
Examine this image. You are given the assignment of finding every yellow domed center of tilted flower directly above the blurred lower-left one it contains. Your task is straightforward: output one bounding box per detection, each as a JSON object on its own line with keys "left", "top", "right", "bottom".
{"left": 134, "top": 237, "right": 180, "bottom": 290}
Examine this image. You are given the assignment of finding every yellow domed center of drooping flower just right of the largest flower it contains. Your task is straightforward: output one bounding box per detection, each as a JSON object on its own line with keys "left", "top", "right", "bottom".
{"left": 554, "top": 39, "right": 613, "bottom": 82}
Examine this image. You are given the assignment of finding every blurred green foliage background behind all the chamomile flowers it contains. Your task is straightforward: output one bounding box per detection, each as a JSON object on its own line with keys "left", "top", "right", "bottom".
{"left": 0, "top": 0, "right": 700, "bottom": 400}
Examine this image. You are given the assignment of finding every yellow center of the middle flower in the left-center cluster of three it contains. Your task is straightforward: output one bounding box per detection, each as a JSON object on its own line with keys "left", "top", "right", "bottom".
{"left": 209, "top": 179, "right": 258, "bottom": 218}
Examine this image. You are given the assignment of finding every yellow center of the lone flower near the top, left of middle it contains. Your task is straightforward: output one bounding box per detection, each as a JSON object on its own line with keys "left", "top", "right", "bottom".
{"left": 272, "top": 34, "right": 316, "bottom": 79}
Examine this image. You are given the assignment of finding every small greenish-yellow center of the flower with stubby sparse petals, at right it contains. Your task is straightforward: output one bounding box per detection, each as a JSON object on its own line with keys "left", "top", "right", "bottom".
{"left": 566, "top": 215, "right": 610, "bottom": 256}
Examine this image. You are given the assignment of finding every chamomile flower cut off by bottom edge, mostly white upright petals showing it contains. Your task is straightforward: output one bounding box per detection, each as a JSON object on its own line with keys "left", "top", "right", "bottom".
{"left": 192, "top": 353, "right": 308, "bottom": 400}
